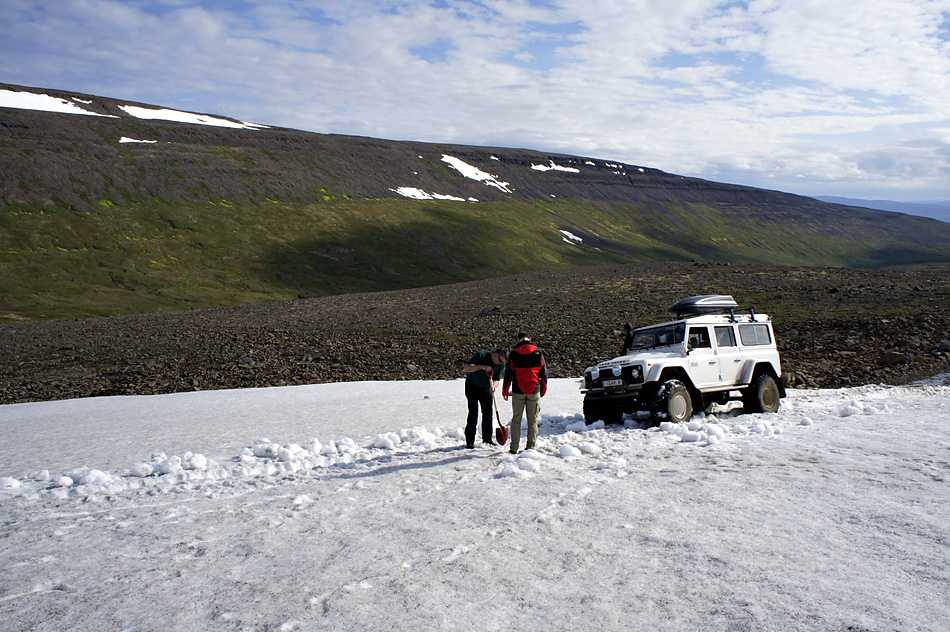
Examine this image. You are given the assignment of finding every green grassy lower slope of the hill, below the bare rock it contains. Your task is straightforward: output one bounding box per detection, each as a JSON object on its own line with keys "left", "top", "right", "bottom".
{"left": 0, "top": 190, "right": 948, "bottom": 320}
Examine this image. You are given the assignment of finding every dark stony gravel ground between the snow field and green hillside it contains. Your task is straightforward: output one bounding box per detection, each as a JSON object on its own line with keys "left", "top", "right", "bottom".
{"left": 0, "top": 262, "right": 950, "bottom": 404}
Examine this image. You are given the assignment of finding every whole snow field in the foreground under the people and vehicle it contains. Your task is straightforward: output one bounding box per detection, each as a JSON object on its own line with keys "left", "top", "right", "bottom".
{"left": 0, "top": 380, "right": 950, "bottom": 632}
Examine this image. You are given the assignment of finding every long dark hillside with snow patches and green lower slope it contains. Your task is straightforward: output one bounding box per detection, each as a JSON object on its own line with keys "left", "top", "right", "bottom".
{"left": 0, "top": 85, "right": 950, "bottom": 320}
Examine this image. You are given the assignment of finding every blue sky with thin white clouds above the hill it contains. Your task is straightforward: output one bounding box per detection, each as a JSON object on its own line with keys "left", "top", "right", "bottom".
{"left": 0, "top": 0, "right": 950, "bottom": 201}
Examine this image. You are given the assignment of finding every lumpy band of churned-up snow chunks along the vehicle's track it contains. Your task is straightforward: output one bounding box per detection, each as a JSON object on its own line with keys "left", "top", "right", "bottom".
{"left": 0, "top": 380, "right": 924, "bottom": 501}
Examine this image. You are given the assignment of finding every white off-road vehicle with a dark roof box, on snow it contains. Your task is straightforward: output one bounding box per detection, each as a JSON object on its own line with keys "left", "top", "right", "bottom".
{"left": 582, "top": 295, "right": 785, "bottom": 424}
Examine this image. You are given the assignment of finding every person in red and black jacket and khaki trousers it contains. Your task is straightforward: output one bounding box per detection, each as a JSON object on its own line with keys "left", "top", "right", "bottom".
{"left": 501, "top": 332, "right": 548, "bottom": 454}
